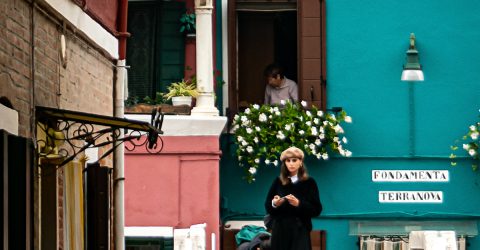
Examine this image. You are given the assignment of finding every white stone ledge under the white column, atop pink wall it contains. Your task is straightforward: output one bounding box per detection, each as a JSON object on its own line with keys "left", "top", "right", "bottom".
{"left": 125, "top": 114, "right": 227, "bottom": 136}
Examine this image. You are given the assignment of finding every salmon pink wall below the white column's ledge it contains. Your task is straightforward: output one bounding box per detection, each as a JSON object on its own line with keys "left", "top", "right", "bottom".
{"left": 125, "top": 136, "right": 220, "bottom": 249}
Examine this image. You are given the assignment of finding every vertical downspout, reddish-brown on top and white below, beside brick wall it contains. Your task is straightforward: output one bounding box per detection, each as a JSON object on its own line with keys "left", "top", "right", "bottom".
{"left": 113, "top": 0, "right": 129, "bottom": 250}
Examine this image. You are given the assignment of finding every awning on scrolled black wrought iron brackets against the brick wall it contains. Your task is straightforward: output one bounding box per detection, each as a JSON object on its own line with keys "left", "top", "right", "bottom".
{"left": 35, "top": 106, "right": 164, "bottom": 167}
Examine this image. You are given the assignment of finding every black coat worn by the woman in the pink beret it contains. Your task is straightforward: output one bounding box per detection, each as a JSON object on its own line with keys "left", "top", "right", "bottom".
{"left": 265, "top": 178, "right": 322, "bottom": 250}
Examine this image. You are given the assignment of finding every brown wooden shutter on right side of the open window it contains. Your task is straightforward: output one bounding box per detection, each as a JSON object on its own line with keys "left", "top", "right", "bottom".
{"left": 298, "top": 0, "right": 326, "bottom": 109}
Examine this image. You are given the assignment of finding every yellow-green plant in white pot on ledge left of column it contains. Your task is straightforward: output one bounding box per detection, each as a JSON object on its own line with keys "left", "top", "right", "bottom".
{"left": 164, "top": 79, "right": 198, "bottom": 106}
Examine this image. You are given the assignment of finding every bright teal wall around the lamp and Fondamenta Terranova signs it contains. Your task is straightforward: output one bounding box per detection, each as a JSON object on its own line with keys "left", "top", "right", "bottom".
{"left": 220, "top": 0, "right": 480, "bottom": 250}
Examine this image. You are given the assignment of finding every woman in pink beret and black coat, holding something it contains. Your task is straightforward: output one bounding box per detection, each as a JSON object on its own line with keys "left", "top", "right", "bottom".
{"left": 265, "top": 147, "right": 322, "bottom": 250}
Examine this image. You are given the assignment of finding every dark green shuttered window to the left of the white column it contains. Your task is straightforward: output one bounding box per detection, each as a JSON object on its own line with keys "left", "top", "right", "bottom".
{"left": 127, "top": 1, "right": 185, "bottom": 100}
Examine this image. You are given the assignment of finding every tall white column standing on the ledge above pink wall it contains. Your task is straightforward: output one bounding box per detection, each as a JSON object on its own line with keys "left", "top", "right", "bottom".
{"left": 191, "top": 0, "right": 219, "bottom": 116}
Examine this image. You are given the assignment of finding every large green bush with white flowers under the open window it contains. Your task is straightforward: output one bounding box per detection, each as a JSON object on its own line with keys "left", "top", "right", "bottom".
{"left": 233, "top": 101, "right": 352, "bottom": 182}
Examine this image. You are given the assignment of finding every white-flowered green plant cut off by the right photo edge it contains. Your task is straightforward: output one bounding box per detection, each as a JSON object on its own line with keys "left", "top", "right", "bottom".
{"left": 450, "top": 110, "right": 480, "bottom": 170}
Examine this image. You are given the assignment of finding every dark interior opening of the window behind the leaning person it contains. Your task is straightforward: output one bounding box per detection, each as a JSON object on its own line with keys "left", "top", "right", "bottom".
{"left": 237, "top": 11, "right": 298, "bottom": 110}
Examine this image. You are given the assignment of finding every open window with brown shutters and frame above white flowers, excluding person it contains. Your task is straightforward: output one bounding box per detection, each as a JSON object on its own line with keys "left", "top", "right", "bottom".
{"left": 228, "top": 0, "right": 326, "bottom": 115}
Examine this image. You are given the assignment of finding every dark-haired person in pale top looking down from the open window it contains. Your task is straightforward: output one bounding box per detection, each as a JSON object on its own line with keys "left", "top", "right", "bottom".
{"left": 263, "top": 63, "right": 298, "bottom": 105}
